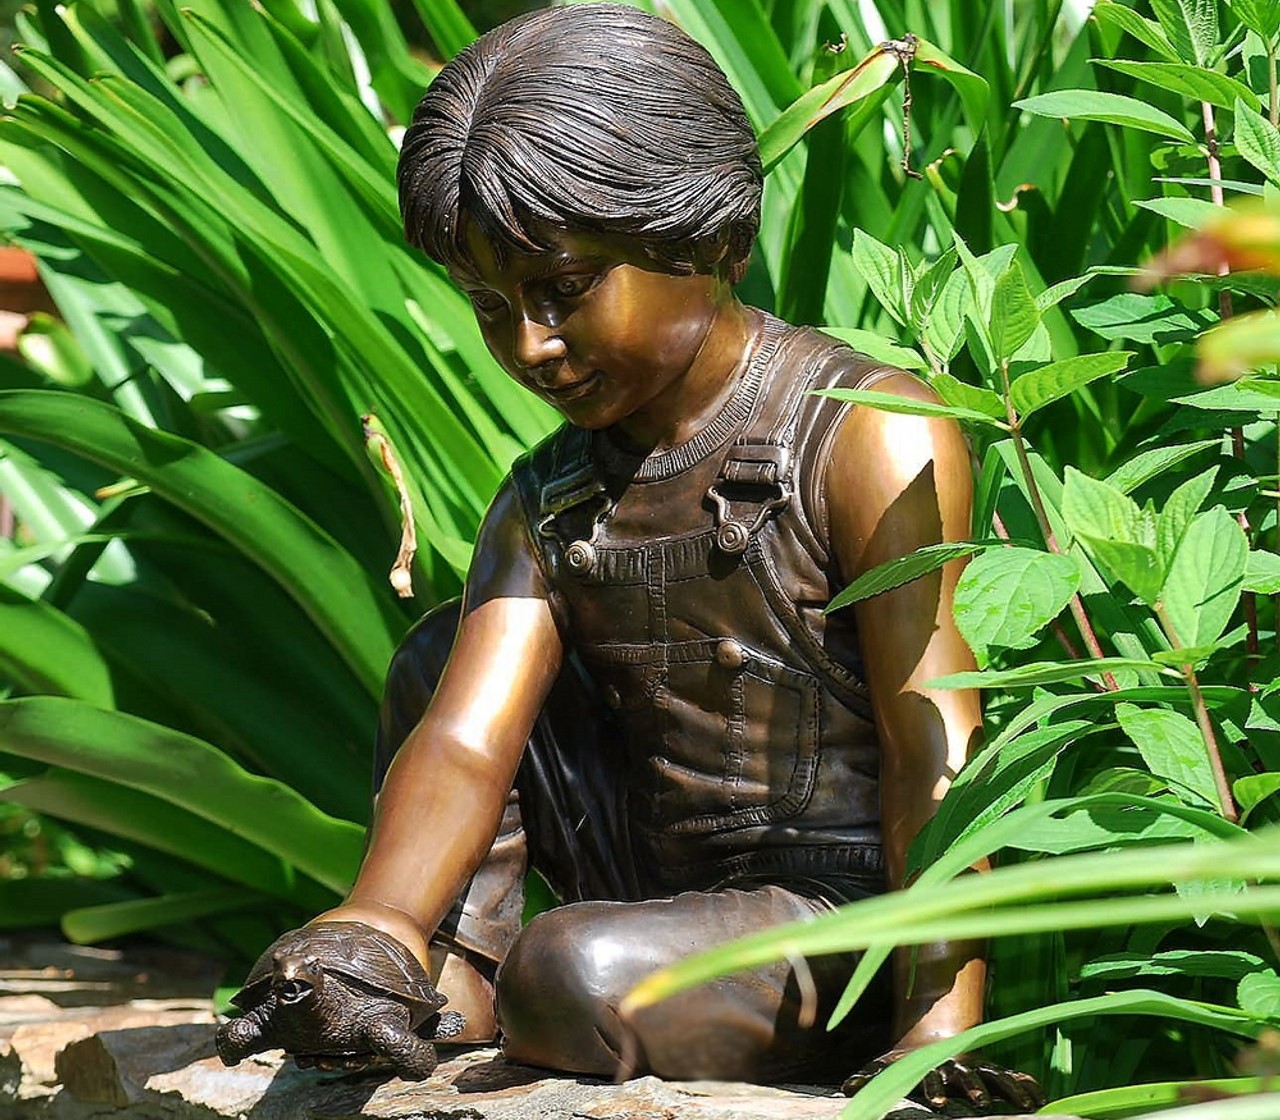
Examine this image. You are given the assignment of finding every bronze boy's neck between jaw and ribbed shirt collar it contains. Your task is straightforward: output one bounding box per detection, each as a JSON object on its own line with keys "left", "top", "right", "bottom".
{"left": 617, "top": 302, "right": 759, "bottom": 452}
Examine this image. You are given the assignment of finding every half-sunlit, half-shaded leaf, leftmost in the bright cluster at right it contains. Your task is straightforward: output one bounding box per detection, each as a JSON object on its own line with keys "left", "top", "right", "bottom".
{"left": 1062, "top": 467, "right": 1167, "bottom": 604}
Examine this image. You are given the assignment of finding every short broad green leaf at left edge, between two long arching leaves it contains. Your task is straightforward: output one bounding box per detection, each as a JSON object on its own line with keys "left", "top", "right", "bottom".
{"left": 0, "top": 584, "right": 115, "bottom": 708}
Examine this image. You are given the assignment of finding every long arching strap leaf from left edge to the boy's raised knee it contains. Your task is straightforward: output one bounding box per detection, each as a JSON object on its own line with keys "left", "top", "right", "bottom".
{"left": 0, "top": 389, "right": 404, "bottom": 695}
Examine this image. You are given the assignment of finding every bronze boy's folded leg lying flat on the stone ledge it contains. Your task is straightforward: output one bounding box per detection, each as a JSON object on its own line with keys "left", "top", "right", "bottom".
{"left": 498, "top": 886, "right": 888, "bottom": 1080}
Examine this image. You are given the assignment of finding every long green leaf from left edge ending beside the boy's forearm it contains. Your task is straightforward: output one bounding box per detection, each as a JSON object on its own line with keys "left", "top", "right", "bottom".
{"left": 0, "top": 698, "right": 364, "bottom": 892}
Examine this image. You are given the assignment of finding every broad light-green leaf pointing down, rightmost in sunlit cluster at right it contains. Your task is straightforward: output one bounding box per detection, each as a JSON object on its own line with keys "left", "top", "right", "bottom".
{"left": 1160, "top": 506, "right": 1249, "bottom": 646}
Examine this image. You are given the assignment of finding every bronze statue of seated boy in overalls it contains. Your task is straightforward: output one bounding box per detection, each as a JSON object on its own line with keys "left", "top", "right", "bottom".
{"left": 217, "top": 4, "right": 1036, "bottom": 1106}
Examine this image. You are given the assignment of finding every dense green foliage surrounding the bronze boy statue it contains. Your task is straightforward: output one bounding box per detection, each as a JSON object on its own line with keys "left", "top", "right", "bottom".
{"left": 0, "top": 0, "right": 1280, "bottom": 1116}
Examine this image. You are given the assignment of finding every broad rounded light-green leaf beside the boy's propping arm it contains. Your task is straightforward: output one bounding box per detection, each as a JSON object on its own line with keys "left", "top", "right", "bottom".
{"left": 955, "top": 548, "right": 1080, "bottom": 668}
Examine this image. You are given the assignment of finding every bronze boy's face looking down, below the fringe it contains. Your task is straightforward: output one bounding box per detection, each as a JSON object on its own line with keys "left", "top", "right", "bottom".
{"left": 451, "top": 223, "right": 731, "bottom": 430}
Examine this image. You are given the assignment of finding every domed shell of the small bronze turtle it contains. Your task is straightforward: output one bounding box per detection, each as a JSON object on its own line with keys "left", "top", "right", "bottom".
{"left": 232, "top": 922, "right": 447, "bottom": 1021}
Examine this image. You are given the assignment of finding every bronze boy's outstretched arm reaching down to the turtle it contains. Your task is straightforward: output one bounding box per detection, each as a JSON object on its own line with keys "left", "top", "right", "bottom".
{"left": 316, "top": 481, "right": 563, "bottom": 966}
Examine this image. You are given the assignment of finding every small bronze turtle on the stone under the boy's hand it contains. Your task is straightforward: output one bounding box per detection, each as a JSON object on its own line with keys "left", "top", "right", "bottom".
{"left": 216, "top": 922, "right": 465, "bottom": 1080}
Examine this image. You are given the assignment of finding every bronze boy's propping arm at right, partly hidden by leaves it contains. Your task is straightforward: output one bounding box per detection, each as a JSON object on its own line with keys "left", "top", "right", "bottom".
{"left": 826, "top": 374, "right": 1038, "bottom": 1108}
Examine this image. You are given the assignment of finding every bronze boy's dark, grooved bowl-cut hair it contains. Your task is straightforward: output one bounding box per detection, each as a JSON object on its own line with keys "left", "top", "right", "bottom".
{"left": 398, "top": 4, "right": 763, "bottom": 280}
